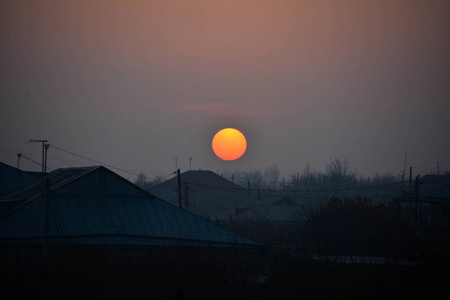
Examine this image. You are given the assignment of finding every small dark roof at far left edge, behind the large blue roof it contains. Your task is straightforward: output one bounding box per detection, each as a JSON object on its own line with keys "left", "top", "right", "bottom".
{"left": 0, "top": 162, "right": 41, "bottom": 195}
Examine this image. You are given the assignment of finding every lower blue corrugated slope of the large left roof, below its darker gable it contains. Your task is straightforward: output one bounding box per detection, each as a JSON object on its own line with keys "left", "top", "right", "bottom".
{"left": 0, "top": 195, "right": 257, "bottom": 246}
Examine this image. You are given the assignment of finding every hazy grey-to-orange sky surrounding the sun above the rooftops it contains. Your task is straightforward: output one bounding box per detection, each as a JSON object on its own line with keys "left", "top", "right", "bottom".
{"left": 0, "top": 0, "right": 450, "bottom": 180}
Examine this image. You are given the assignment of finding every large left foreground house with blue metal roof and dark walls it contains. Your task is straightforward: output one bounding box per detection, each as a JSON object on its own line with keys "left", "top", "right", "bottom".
{"left": 0, "top": 166, "right": 266, "bottom": 299}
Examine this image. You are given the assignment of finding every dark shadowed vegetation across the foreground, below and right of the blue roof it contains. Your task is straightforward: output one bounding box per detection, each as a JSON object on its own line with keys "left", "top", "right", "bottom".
{"left": 0, "top": 198, "right": 450, "bottom": 299}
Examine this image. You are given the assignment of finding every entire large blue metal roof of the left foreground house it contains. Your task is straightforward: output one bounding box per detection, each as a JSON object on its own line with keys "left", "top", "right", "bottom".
{"left": 0, "top": 166, "right": 260, "bottom": 247}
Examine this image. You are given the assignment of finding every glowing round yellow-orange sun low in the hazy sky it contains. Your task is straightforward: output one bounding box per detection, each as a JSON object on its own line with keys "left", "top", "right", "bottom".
{"left": 212, "top": 128, "right": 247, "bottom": 160}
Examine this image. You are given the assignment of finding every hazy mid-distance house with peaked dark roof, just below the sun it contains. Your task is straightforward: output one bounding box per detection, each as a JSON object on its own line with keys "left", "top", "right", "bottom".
{"left": 150, "top": 170, "right": 249, "bottom": 217}
